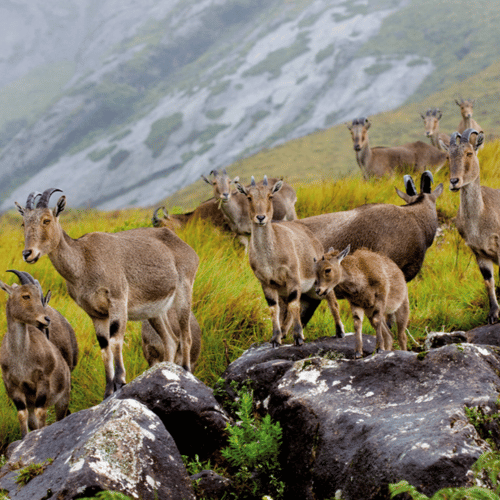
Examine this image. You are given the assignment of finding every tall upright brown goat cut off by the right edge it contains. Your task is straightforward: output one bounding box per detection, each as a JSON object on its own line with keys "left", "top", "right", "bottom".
{"left": 442, "top": 129, "right": 500, "bottom": 324}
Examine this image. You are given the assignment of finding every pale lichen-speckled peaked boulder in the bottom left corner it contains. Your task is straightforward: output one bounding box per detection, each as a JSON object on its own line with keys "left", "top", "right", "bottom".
{"left": 0, "top": 399, "right": 195, "bottom": 500}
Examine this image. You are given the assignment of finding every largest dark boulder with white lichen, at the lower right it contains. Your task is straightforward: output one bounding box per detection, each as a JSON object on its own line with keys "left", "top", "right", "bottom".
{"left": 269, "top": 344, "right": 500, "bottom": 500}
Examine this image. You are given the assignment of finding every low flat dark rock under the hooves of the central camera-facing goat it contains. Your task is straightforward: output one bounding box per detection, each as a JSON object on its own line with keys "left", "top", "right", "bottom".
{"left": 222, "top": 333, "right": 376, "bottom": 402}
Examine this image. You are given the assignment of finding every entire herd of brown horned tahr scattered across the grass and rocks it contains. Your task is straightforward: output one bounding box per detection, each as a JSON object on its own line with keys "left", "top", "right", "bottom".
{"left": 0, "top": 96, "right": 494, "bottom": 437}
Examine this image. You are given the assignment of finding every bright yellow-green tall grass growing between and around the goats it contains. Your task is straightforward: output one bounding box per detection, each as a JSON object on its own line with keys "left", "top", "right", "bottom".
{"left": 0, "top": 134, "right": 500, "bottom": 451}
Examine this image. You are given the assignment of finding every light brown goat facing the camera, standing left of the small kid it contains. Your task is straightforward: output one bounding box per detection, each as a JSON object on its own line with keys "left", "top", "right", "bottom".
{"left": 236, "top": 177, "right": 323, "bottom": 347}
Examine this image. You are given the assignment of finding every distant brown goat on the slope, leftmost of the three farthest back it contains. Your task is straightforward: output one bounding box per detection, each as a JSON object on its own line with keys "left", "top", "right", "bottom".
{"left": 347, "top": 118, "right": 448, "bottom": 179}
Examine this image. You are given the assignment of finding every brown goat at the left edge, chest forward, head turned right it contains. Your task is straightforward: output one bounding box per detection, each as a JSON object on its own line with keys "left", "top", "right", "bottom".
{"left": 0, "top": 270, "right": 78, "bottom": 437}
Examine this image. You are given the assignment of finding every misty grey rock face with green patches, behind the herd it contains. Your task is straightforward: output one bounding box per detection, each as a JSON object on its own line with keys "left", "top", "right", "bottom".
{"left": 0, "top": 0, "right": 433, "bottom": 210}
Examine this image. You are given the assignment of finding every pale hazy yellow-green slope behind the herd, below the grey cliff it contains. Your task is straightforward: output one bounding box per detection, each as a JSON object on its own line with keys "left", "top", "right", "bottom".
{"left": 165, "top": 61, "right": 500, "bottom": 209}
